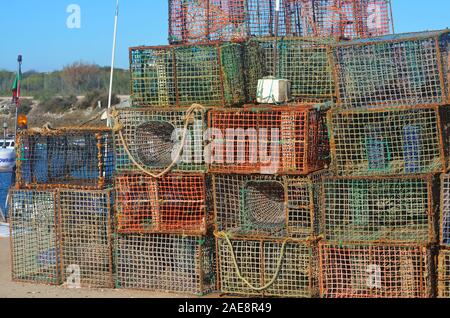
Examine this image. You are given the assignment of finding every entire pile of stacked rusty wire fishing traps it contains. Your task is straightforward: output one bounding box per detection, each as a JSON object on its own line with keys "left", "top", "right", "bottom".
{"left": 10, "top": 0, "right": 450, "bottom": 298}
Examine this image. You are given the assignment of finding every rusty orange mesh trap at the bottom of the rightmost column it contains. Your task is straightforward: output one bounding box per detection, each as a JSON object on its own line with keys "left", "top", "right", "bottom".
{"left": 319, "top": 243, "right": 431, "bottom": 298}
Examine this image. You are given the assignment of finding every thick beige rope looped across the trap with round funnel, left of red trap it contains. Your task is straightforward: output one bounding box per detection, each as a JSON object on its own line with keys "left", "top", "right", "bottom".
{"left": 111, "top": 104, "right": 206, "bottom": 179}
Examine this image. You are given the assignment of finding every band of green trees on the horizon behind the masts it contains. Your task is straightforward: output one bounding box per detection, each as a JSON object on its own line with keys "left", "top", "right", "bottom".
{"left": 0, "top": 62, "right": 130, "bottom": 97}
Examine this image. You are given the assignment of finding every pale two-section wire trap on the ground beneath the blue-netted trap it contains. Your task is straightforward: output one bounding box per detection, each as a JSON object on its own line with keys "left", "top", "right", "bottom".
{"left": 10, "top": 189, "right": 113, "bottom": 288}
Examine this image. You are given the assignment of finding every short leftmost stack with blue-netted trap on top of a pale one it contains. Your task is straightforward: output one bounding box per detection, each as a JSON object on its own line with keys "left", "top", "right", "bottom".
{"left": 9, "top": 128, "right": 114, "bottom": 287}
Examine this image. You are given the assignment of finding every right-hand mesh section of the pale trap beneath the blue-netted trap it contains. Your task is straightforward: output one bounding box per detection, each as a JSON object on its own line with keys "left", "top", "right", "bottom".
{"left": 59, "top": 190, "right": 114, "bottom": 288}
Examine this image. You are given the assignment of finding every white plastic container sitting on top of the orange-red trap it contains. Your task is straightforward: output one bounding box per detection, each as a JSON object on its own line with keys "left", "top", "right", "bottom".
{"left": 256, "top": 77, "right": 291, "bottom": 104}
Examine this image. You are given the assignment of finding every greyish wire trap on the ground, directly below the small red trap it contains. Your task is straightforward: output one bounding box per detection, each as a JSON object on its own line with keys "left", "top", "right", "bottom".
{"left": 115, "top": 234, "right": 216, "bottom": 295}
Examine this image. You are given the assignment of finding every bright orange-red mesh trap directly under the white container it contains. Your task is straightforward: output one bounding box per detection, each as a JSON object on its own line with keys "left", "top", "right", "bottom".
{"left": 208, "top": 104, "right": 329, "bottom": 175}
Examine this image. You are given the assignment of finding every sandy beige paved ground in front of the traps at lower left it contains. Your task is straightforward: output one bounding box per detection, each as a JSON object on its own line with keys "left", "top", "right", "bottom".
{"left": 0, "top": 238, "right": 220, "bottom": 298}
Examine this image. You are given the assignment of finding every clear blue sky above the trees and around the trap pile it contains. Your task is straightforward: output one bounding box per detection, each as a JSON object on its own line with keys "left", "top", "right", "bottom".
{"left": 0, "top": 0, "right": 450, "bottom": 71}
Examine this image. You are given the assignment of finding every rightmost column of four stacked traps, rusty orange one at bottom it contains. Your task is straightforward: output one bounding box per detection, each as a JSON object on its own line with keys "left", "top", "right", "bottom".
{"left": 319, "top": 31, "right": 450, "bottom": 298}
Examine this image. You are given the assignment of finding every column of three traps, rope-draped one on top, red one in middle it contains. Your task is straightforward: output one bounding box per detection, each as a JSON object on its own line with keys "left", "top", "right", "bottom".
{"left": 114, "top": 107, "right": 216, "bottom": 295}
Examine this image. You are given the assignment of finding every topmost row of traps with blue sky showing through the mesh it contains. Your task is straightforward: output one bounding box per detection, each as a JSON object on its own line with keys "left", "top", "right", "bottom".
{"left": 169, "top": 0, "right": 392, "bottom": 43}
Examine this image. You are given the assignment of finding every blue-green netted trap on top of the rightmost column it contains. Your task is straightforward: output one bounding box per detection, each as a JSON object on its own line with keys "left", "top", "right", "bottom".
{"left": 333, "top": 30, "right": 450, "bottom": 109}
